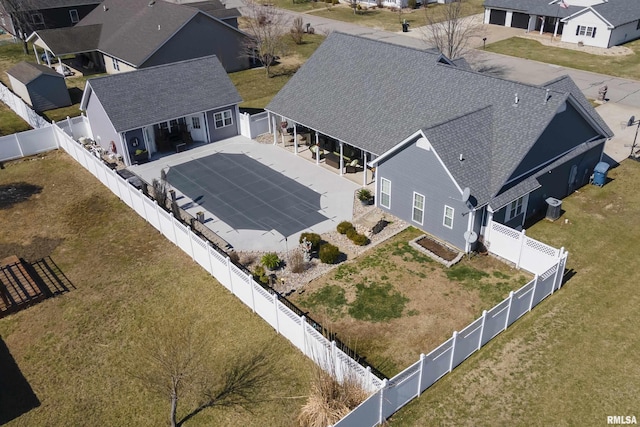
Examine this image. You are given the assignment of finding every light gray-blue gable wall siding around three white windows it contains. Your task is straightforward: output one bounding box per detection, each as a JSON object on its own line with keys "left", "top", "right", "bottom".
{"left": 376, "top": 137, "right": 469, "bottom": 250}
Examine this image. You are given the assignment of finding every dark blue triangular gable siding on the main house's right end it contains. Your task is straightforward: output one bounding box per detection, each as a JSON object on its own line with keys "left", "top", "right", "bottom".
{"left": 509, "top": 103, "right": 598, "bottom": 184}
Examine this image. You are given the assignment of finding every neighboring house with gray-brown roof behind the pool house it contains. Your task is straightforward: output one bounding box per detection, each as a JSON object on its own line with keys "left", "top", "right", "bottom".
{"left": 29, "top": 0, "right": 250, "bottom": 74}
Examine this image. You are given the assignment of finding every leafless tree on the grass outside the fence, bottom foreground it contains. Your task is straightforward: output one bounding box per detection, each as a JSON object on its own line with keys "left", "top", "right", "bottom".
{"left": 131, "top": 321, "right": 273, "bottom": 427}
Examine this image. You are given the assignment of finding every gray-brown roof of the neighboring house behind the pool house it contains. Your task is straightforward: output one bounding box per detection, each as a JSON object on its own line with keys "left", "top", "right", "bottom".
{"left": 29, "top": 0, "right": 245, "bottom": 68}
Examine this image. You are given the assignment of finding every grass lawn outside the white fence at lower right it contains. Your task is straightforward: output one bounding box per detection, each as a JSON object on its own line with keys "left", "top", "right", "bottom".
{"left": 391, "top": 160, "right": 640, "bottom": 426}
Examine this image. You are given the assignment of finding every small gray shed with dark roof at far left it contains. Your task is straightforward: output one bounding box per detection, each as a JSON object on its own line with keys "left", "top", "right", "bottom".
{"left": 7, "top": 61, "right": 71, "bottom": 111}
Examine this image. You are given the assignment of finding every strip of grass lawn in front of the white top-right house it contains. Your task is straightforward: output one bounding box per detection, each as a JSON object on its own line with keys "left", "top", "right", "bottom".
{"left": 487, "top": 37, "right": 640, "bottom": 80}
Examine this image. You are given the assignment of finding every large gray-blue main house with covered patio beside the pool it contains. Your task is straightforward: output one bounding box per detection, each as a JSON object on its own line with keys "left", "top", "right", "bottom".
{"left": 266, "top": 33, "right": 613, "bottom": 254}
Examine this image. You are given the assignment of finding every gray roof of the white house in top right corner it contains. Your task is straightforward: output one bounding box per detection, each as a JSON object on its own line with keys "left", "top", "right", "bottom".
{"left": 484, "top": 0, "right": 640, "bottom": 27}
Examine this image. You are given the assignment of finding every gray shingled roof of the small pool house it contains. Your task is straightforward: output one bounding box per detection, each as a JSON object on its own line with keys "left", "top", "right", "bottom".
{"left": 81, "top": 56, "right": 242, "bottom": 132}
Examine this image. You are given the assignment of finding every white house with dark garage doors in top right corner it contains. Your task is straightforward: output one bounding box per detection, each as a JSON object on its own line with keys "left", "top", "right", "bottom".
{"left": 484, "top": 0, "right": 640, "bottom": 48}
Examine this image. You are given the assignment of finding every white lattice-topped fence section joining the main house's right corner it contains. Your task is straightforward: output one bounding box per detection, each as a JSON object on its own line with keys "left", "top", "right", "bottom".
{"left": 485, "top": 221, "right": 564, "bottom": 274}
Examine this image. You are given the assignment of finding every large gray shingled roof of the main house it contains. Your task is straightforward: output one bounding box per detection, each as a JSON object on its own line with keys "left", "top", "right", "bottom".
{"left": 266, "top": 33, "right": 608, "bottom": 204}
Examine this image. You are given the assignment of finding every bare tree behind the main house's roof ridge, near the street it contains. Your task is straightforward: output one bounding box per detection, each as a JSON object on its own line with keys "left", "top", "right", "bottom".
{"left": 423, "top": 0, "right": 481, "bottom": 59}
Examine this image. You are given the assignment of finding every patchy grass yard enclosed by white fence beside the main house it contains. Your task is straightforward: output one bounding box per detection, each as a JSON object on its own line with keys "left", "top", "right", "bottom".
{"left": 291, "top": 227, "right": 530, "bottom": 376}
